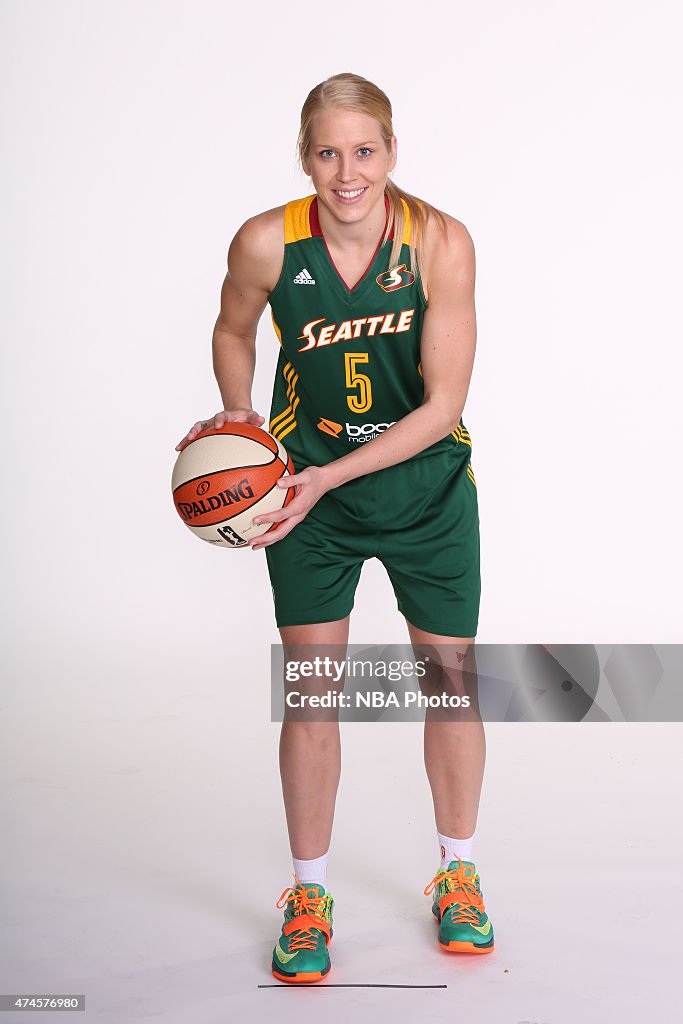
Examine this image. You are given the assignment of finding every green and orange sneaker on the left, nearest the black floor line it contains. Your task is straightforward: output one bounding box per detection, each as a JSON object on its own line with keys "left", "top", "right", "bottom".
{"left": 271, "top": 877, "right": 335, "bottom": 983}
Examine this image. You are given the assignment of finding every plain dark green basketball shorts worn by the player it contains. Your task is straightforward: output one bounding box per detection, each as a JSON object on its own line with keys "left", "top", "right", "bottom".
{"left": 265, "top": 445, "right": 481, "bottom": 637}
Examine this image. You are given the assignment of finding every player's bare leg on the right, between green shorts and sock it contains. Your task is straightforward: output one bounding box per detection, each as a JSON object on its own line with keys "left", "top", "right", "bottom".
{"left": 407, "top": 623, "right": 486, "bottom": 839}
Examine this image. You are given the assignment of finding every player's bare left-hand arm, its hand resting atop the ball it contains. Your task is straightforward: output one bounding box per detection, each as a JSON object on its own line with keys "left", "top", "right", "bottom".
{"left": 176, "top": 208, "right": 285, "bottom": 452}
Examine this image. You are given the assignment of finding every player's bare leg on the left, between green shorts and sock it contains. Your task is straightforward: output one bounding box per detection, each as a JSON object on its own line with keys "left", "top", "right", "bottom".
{"left": 280, "top": 615, "right": 349, "bottom": 860}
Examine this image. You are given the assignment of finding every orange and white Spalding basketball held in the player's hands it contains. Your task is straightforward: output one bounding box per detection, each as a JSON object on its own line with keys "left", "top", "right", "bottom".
{"left": 171, "top": 423, "right": 295, "bottom": 548}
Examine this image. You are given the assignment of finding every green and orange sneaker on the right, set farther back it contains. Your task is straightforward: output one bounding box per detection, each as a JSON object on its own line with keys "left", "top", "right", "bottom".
{"left": 424, "top": 857, "right": 494, "bottom": 953}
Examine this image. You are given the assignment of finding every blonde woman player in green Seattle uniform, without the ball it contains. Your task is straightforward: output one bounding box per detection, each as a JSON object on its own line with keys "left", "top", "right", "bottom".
{"left": 177, "top": 74, "right": 494, "bottom": 982}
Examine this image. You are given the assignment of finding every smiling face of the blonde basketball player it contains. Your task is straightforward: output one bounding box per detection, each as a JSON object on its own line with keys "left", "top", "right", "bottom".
{"left": 302, "top": 108, "right": 396, "bottom": 222}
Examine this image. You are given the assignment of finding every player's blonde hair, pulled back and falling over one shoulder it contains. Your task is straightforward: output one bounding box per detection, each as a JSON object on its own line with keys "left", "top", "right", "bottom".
{"left": 297, "top": 72, "right": 447, "bottom": 284}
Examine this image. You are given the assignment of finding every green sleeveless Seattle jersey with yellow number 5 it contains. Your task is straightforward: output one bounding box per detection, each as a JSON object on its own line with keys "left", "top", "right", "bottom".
{"left": 268, "top": 195, "right": 474, "bottom": 482}
